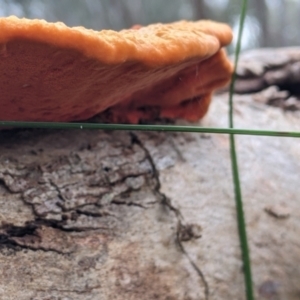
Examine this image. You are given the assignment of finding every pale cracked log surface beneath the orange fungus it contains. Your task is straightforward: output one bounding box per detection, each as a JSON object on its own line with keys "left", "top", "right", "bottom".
{"left": 0, "top": 47, "right": 300, "bottom": 300}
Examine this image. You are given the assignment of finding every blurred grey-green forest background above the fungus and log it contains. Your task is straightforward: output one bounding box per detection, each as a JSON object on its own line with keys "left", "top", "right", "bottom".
{"left": 0, "top": 0, "right": 300, "bottom": 49}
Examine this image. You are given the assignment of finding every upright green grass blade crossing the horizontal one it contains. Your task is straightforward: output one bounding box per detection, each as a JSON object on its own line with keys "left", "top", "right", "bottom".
{"left": 229, "top": 0, "right": 254, "bottom": 300}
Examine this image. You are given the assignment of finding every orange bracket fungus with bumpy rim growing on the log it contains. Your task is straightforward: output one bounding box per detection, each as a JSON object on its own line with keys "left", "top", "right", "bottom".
{"left": 0, "top": 17, "right": 232, "bottom": 123}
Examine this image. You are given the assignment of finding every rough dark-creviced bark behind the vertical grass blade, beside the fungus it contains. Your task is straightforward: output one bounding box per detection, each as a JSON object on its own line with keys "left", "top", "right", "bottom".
{"left": 235, "top": 47, "right": 300, "bottom": 110}
